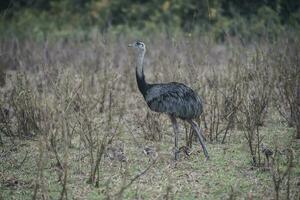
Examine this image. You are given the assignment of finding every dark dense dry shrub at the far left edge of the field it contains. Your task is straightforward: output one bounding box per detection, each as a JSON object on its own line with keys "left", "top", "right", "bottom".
{"left": 0, "top": 73, "right": 41, "bottom": 140}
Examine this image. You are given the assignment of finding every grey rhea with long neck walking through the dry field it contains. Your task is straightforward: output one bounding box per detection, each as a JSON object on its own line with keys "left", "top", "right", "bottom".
{"left": 128, "top": 41, "right": 209, "bottom": 160}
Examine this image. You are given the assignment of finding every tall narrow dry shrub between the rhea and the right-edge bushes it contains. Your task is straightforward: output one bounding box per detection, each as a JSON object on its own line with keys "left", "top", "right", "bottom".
{"left": 238, "top": 49, "right": 273, "bottom": 166}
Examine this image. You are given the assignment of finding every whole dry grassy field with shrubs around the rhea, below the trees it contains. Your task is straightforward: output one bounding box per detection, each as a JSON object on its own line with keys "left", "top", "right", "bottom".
{"left": 0, "top": 33, "right": 300, "bottom": 199}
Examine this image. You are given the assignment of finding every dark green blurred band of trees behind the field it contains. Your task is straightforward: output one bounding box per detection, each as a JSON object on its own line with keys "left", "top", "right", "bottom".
{"left": 0, "top": 0, "right": 300, "bottom": 39}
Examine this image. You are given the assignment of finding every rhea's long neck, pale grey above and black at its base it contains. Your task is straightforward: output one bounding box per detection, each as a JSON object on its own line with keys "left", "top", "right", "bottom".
{"left": 136, "top": 50, "right": 149, "bottom": 97}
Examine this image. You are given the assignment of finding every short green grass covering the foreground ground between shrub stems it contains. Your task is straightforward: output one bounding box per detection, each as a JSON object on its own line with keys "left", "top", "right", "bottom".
{"left": 0, "top": 119, "right": 299, "bottom": 199}
